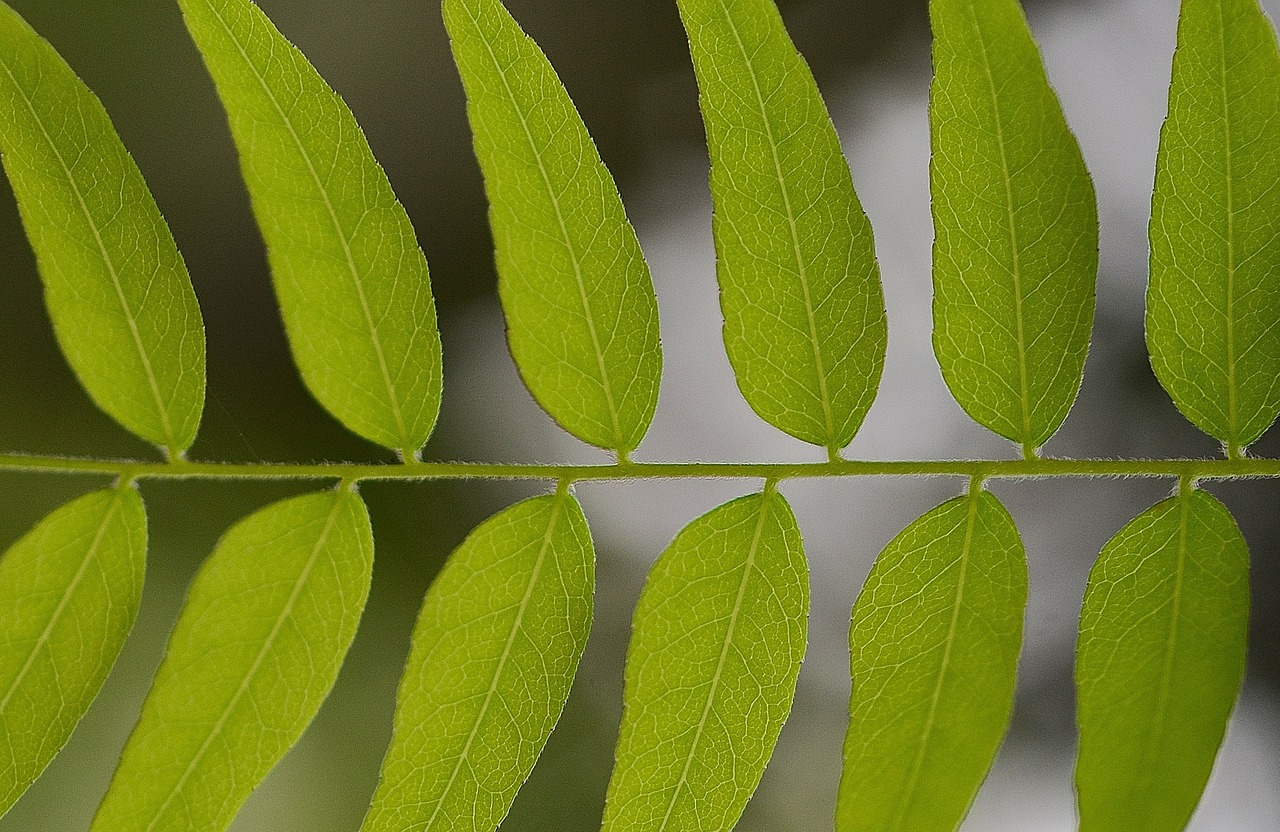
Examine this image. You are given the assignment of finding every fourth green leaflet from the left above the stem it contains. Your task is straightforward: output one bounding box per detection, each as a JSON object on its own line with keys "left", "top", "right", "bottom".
{"left": 680, "top": 0, "right": 888, "bottom": 457}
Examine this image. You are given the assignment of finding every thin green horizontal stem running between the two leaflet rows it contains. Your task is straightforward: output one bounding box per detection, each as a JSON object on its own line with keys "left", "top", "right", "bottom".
{"left": 0, "top": 453, "right": 1280, "bottom": 483}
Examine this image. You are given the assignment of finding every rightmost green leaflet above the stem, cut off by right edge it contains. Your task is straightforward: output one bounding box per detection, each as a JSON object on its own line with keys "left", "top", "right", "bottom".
{"left": 1147, "top": 0, "right": 1280, "bottom": 456}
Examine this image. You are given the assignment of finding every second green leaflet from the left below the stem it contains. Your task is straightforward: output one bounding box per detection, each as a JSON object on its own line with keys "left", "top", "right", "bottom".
{"left": 92, "top": 492, "right": 374, "bottom": 832}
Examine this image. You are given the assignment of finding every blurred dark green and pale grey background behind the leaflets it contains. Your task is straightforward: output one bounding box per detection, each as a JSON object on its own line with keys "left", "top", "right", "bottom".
{"left": 0, "top": 0, "right": 1280, "bottom": 832}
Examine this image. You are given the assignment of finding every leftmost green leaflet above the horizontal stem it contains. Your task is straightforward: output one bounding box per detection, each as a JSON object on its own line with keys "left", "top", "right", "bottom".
{"left": 0, "top": 3, "right": 205, "bottom": 457}
